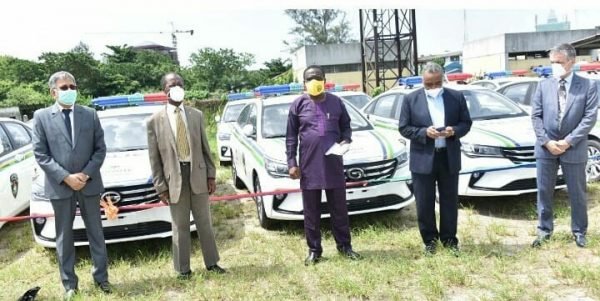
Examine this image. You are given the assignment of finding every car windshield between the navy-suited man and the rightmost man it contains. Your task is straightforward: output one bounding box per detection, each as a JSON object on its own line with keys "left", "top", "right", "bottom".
{"left": 462, "top": 90, "right": 527, "bottom": 120}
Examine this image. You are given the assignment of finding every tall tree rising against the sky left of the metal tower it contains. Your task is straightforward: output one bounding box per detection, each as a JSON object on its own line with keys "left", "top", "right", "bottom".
{"left": 283, "top": 9, "right": 351, "bottom": 53}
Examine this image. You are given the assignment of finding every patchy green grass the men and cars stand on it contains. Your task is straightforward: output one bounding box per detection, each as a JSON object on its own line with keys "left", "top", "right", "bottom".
{"left": 0, "top": 111, "right": 600, "bottom": 300}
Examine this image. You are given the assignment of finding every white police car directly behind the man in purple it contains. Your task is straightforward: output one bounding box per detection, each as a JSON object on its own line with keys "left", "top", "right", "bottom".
{"left": 231, "top": 84, "right": 414, "bottom": 228}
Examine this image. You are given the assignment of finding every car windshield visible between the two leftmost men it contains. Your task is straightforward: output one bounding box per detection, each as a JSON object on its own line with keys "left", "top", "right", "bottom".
{"left": 100, "top": 114, "right": 150, "bottom": 152}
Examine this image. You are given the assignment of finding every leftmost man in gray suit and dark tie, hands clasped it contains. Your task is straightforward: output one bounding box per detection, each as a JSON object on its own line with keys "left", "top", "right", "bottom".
{"left": 33, "top": 71, "right": 111, "bottom": 299}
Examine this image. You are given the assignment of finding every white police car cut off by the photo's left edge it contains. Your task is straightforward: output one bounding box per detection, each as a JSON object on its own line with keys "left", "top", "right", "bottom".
{"left": 0, "top": 118, "right": 36, "bottom": 227}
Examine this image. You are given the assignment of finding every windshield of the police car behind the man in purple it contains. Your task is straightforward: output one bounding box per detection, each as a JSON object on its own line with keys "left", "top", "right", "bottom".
{"left": 262, "top": 103, "right": 373, "bottom": 138}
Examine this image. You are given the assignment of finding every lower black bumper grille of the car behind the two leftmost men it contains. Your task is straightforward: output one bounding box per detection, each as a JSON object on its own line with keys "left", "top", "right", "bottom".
{"left": 73, "top": 222, "right": 171, "bottom": 242}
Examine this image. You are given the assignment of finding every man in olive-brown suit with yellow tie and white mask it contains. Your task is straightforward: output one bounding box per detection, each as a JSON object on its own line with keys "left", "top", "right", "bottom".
{"left": 147, "top": 73, "right": 225, "bottom": 279}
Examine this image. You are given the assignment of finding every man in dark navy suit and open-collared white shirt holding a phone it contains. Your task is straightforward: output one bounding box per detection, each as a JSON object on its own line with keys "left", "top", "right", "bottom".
{"left": 399, "top": 63, "right": 472, "bottom": 253}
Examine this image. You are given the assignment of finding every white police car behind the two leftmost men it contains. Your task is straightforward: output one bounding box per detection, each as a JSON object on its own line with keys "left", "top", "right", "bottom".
{"left": 30, "top": 93, "right": 195, "bottom": 248}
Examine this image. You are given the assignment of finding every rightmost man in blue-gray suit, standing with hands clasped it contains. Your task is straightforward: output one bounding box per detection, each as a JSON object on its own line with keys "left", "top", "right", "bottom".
{"left": 531, "top": 44, "right": 598, "bottom": 248}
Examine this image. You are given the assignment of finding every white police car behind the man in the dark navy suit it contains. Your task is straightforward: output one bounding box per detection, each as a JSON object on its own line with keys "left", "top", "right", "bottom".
{"left": 363, "top": 77, "right": 564, "bottom": 196}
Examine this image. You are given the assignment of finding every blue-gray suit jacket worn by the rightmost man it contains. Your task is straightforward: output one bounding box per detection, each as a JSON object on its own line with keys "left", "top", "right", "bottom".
{"left": 531, "top": 74, "right": 598, "bottom": 163}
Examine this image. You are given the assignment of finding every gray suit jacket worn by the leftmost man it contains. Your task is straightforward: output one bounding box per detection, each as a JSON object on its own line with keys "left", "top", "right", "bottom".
{"left": 33, "top": 105, "right": 106, "bottom": 199}
